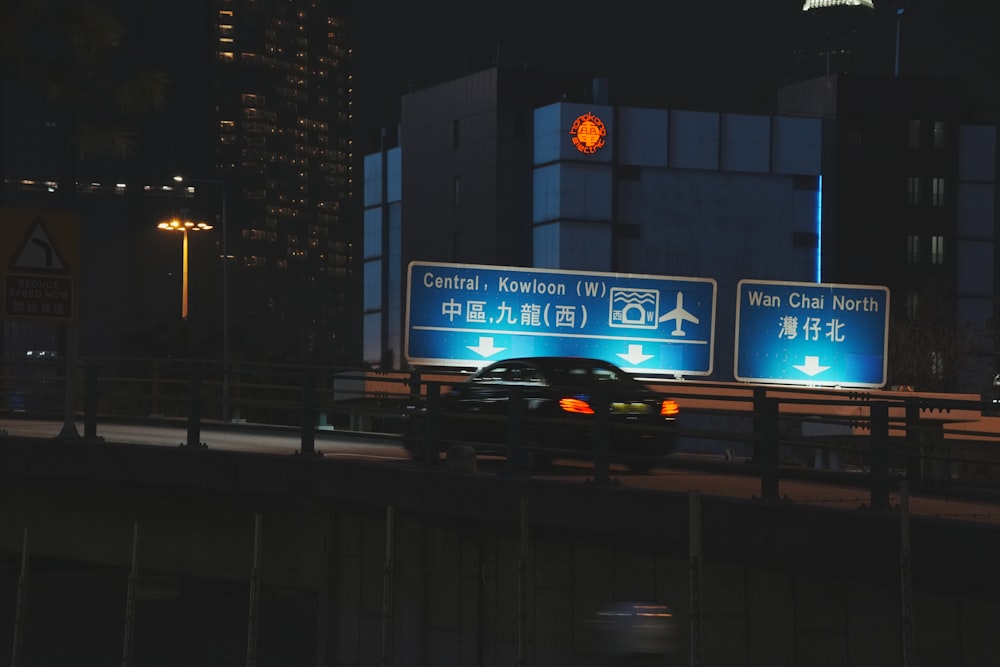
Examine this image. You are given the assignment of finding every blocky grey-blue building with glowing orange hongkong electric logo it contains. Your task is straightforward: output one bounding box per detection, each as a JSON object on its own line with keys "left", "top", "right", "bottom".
{"left": 364, "top": 68, "right": 997, "bottom": 390}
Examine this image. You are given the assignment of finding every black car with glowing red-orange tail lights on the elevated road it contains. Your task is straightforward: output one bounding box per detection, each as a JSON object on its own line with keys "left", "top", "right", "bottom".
{"left": 404, "top": 357, "right": 679, "bottom": 470}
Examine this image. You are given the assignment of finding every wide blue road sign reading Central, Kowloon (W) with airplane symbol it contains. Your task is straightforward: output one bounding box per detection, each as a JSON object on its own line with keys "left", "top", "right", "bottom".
{"left": 405, "top": 262, "right": 716, "bottom": 375}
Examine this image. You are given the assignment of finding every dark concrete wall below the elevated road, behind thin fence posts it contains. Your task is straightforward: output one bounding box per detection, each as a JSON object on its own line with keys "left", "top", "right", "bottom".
{"left": 0, "top": 438, "right": 1000, "bottom": 667}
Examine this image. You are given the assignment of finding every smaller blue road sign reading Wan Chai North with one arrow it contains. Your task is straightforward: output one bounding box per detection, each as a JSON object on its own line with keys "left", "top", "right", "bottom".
{"left": 734, "top": 280, "right": 889, "bottom": 387}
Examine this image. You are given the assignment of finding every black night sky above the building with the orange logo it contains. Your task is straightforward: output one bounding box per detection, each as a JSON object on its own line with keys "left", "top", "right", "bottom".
{"left": 354, "top": 0, "right": 1000, "bottom": 150}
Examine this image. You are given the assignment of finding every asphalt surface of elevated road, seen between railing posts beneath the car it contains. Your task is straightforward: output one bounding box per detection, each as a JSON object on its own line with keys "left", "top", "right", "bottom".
{"left": 0, "top": 419, "right": 1000, "bottom": 524}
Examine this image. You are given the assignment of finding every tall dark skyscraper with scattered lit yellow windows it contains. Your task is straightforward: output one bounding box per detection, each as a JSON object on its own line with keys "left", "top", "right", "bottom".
{"left": 195, "top": 0, "right": 353, "bottom": 362}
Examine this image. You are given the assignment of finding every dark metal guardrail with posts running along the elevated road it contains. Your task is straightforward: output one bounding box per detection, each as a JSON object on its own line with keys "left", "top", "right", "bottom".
{"left": 0, "top": 359, "right": 1000, "bottom": 505}
